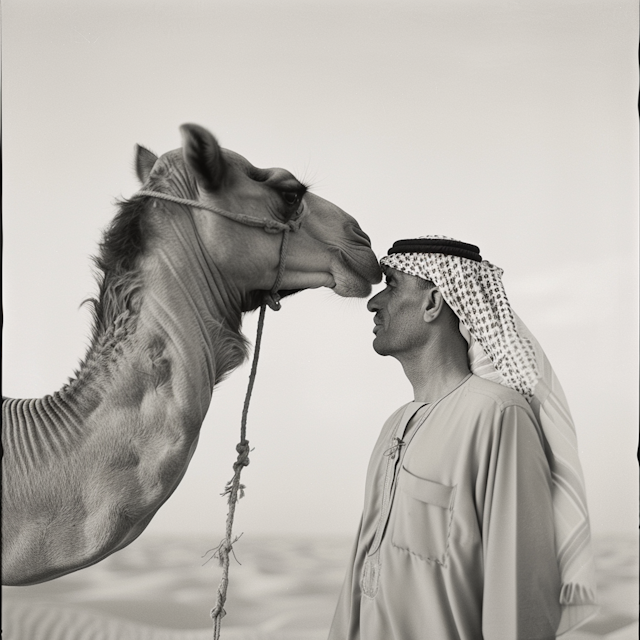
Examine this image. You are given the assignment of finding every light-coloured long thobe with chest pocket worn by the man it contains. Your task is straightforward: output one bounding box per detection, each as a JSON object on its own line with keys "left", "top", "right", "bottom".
{"left": 329, "top": 375, "right": 561, "bottom": 640}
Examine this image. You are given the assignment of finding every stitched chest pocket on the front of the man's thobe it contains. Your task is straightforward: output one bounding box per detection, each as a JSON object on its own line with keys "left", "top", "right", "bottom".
{"left": 391, "top": 466, "right": 456, "bottom": 566}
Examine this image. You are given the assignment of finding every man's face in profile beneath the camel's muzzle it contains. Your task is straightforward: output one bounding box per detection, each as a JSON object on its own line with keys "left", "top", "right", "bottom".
{"left": 367, "top": 267, "right": 429, "bottom": 357}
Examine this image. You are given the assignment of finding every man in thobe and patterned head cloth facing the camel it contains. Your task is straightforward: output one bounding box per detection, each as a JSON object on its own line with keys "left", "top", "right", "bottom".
{"left": 329, "top": 236, "right": 595, "bottom": 640}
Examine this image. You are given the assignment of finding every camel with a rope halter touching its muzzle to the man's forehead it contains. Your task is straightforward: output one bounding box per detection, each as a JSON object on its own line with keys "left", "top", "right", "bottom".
{"left": 2, "top": 124, "right": 381, "bottom": 585}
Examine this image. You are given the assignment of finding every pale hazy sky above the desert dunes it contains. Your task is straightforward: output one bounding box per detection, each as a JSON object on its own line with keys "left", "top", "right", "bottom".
{"left": 2, "top": 0, "right": 638, "bottom": 535}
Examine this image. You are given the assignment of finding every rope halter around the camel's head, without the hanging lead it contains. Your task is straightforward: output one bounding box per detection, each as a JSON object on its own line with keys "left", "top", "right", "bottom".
{"left": 138, "top": 189, "right": 309, "bottom": 311}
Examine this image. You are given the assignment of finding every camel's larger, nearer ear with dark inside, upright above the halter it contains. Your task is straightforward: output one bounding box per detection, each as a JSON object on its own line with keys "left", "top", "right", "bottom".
{"left": 180, "top": 124, "right": 227, "bottom": 191}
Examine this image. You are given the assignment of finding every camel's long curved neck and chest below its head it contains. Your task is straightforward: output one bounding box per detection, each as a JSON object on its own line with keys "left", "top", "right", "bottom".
{"left": 2, "top": 202, "right": 251, "bottom": 584}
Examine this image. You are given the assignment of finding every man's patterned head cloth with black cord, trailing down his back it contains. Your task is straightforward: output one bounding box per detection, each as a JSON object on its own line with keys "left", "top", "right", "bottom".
{"left": 380, "top": 236, "right": 597, "bottom": 635}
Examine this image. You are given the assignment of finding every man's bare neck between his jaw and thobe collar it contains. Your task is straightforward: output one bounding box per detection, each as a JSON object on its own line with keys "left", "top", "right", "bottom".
{"left": 398, "top": 335, "right": 469, "bottom": 402}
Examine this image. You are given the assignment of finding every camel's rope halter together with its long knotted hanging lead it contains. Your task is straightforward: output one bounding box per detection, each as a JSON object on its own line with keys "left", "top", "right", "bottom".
{"left": 138, "top": 190, "right": 309, "bottom": 640}
